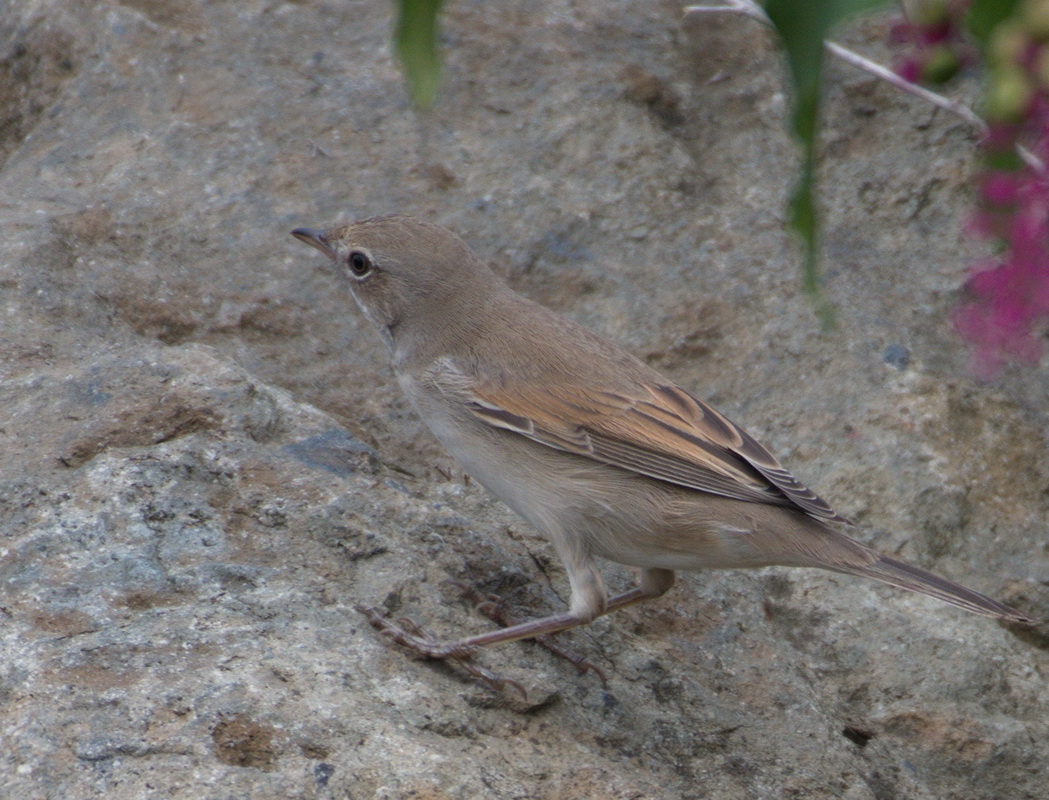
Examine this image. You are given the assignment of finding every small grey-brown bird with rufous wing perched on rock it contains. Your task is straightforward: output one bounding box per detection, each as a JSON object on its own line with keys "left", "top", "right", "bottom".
{"left": 292, "top": 216, "right": 1037, "bottom": 671}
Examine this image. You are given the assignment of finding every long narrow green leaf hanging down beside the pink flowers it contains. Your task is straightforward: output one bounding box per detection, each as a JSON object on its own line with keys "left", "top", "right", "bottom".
{"left": 765, "top": 0, "right": 886, "bottom": 327}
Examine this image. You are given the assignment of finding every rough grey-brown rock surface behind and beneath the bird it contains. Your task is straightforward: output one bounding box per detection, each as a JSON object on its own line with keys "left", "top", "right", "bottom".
{"left": 0, "top": 0, "right": 1049, "bottom": 800}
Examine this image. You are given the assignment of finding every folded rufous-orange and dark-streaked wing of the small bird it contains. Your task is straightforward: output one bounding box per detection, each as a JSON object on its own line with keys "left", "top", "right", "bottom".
{"left": 431, "top": 361, "right": 847, "bottom": 522}
